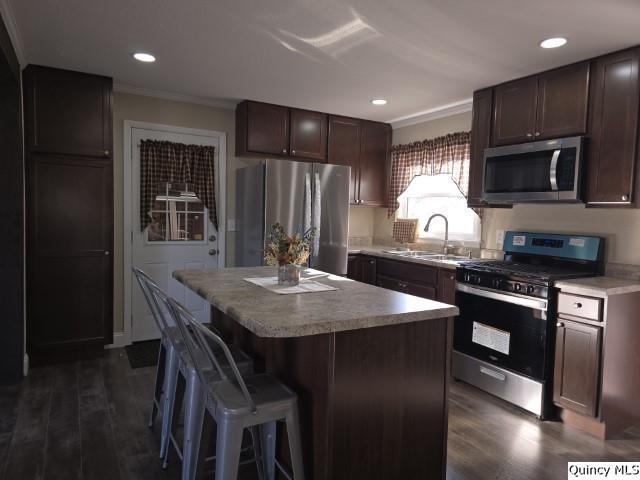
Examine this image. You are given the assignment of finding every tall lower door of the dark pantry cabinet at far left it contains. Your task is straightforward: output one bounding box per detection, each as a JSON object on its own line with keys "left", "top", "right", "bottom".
{"left": 27, "top": 154, "right": 113, "bottom": 363}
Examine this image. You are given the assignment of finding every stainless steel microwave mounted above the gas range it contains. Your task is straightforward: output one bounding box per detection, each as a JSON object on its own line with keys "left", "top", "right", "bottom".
{"left": 482, "top": 137, "right": 583, "bottom": 204}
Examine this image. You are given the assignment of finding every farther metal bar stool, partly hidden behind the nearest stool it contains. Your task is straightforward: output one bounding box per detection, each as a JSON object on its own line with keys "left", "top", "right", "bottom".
{"left": 133, "top": 268, "right": 253, "bottom": 478}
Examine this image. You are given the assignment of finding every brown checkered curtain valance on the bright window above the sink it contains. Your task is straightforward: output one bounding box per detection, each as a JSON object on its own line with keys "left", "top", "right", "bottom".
{"left": 387, "top": 132, "right": 471, "bottom": 217}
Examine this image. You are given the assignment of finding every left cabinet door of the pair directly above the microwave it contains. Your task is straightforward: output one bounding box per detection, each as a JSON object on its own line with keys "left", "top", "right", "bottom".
{"left": 493, "top": 76, "right": 538, "bottom": 145}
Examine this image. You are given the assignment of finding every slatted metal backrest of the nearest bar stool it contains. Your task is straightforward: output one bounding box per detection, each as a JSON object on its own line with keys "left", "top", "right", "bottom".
{"left": 169, "top": 298, "right": 258, "bottom": 413}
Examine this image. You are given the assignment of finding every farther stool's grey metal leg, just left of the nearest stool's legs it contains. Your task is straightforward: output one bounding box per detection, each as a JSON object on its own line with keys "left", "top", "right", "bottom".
{"left": 182, "top": 370, "right": 206, "bottom": 480}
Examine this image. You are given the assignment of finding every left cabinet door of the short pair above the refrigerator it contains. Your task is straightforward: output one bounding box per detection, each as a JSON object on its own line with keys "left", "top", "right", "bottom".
{"left": 246, "top": 102, "right": 289, "bottom": 155}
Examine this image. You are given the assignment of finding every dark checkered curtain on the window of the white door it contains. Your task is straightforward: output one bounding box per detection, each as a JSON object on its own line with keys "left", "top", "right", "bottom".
{"left": 140, "top": 140, "right": 218, "bottom": 230}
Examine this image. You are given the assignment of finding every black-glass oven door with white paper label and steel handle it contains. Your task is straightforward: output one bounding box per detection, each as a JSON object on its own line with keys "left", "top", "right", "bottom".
{"left": 453, "top": 284, "right": 548, "bottom": 380}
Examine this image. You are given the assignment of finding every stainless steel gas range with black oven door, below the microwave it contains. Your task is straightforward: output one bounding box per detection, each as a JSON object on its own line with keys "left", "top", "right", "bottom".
{"left": 452, "top": 232, "right": 604, "bottom": 419}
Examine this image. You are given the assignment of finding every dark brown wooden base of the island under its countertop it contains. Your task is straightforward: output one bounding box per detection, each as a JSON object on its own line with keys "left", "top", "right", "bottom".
{"left": 218, "top": 309, "right": 452, "bottom": 480}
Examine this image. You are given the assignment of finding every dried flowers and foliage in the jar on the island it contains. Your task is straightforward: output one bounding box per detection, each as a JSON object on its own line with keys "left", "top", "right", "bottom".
{"left": 264, "top": 223, "right": 316, "bottom": 266}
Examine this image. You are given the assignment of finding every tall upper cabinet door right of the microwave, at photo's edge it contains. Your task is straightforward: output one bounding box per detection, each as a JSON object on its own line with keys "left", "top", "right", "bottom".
{"left": 585, "top": 48, "right": 640, "bottom": 206}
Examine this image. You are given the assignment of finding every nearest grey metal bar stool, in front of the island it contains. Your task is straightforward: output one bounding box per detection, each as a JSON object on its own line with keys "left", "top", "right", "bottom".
{"left": 168, "top": 299, "right": 304, "bottom": 480}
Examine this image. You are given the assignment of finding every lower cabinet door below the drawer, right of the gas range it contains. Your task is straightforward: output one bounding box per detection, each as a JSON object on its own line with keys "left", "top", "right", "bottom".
{"left": 553, "top": 319, "right": 602, "bottom": 417}
